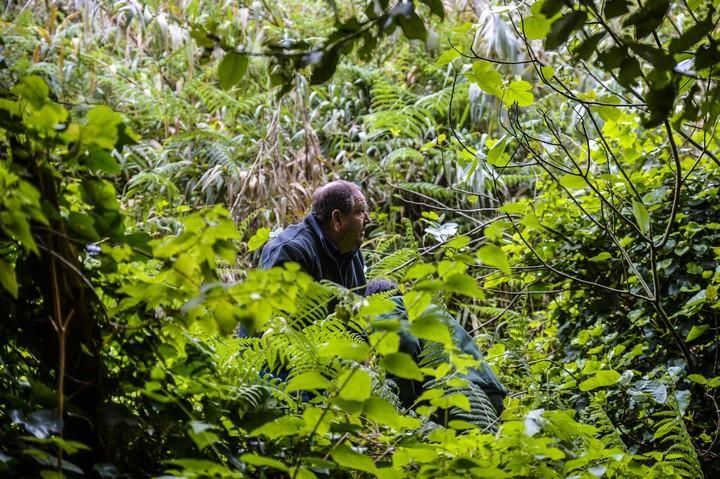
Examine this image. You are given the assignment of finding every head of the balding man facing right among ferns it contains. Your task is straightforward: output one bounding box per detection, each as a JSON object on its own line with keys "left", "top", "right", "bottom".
{"left": 312, "top": 180, "right": 370, "bottom": 253}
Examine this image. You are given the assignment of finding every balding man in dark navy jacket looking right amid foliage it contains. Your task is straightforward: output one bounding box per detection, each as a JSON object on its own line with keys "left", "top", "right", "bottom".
{"left": 260, "top": 180, "right": 370, "bottom": 294}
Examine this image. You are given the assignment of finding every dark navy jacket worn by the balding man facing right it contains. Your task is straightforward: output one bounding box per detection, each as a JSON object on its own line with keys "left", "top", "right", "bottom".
{"left": 260, "top": 215, "right": 366, "bottom": 294}
